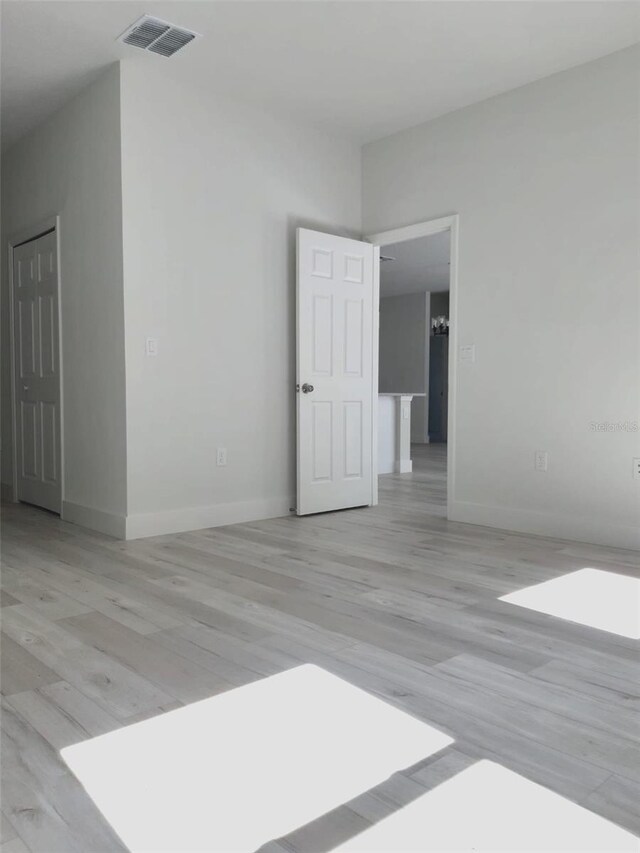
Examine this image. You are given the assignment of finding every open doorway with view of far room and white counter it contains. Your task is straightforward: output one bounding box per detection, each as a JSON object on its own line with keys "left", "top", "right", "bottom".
{"left": 368, "top": 216, "right": 458, "bottom": 515}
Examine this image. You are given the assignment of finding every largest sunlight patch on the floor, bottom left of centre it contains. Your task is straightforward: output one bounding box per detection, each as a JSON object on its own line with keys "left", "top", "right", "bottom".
{"left": 61, "top": 664, "right": 452, "bottom": 853}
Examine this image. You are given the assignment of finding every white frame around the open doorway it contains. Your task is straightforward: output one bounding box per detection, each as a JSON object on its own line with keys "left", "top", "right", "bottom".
{"left": 364, "top": 213, "right": 460, "bottom": 518}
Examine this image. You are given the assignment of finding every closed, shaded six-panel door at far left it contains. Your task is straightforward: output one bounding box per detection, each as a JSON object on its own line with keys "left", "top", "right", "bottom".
{"left": 13, "top": 226, "right": 61, "bottom": 512}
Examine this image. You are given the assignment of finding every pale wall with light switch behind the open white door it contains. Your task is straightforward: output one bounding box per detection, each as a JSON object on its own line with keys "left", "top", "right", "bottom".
{"left": 122, "top": 64, "right": 361, "bottom": 536}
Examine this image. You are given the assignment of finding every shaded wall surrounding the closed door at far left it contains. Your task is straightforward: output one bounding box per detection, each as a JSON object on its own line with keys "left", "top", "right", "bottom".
{"left": 2, "top": 65, "right": 126, "bottom": 533}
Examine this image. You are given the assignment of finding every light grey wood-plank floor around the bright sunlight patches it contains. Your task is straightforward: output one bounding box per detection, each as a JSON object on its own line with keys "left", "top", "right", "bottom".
{"left": 2, "top": 446, "right": 640, "bottom": 853}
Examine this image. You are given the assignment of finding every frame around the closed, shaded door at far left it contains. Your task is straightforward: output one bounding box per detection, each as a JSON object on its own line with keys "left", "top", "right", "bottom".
{"left": 7, "top": 214, "right": 65, "bottom": 506}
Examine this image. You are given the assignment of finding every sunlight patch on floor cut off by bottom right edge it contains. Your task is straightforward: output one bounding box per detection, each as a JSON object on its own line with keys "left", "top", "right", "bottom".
{"left": 333, "top": 761, "right": 638, "bottom": 853}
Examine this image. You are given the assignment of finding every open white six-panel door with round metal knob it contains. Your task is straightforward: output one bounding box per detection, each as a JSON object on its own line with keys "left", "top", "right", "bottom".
{"left": 297, "top": 228, "right": 379, "bottom": 515}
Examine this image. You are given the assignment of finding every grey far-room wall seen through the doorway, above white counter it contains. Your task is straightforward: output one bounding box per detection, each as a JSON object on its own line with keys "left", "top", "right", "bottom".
{"left": 378, "top": 293, "right": 430, "bottom": 443}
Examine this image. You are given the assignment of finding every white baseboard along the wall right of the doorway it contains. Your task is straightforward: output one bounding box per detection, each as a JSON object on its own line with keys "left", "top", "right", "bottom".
{"left": 448, "top": 501, "right": 640, "bottom": 551}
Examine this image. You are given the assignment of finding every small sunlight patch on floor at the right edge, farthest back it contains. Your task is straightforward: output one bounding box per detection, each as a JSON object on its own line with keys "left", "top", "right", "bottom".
{"left": 500, "top": 569, "right": 640, "bottom": 640}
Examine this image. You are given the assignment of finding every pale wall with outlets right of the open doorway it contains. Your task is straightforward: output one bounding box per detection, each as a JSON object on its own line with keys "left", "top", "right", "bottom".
{"left": 363, "top": 48, "right": 640, "bottom": 547}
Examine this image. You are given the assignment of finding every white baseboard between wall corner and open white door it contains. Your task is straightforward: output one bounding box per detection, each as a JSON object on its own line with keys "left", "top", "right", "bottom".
{"left": 126, "top": 497, "right": 295, "bottom": 539}
